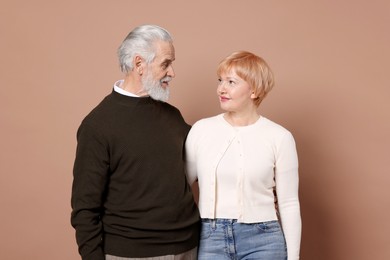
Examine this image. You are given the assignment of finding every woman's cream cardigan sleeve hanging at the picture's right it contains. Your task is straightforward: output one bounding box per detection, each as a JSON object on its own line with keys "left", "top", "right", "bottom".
{"left": 275, "top": 132, "right": 302, "bottom": 260}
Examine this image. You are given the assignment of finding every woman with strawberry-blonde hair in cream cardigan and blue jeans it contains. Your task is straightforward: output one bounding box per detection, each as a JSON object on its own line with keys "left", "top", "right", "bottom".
{"left": 186, "top": 51, "right": 301, "bottom": 260}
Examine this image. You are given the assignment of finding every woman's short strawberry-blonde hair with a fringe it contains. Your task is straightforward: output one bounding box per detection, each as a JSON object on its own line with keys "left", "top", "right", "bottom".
{"left": 217, "top": 51, "right": 274, "bottom": 106}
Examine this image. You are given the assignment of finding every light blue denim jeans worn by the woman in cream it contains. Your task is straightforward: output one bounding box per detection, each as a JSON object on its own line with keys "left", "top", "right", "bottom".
{"left": 198, "top": 219, "right": 287, "bottom": 260}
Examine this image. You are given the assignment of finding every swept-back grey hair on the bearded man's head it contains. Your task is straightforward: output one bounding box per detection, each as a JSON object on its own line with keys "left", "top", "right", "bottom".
{"left": 118, "top": 24, "right": 172, "bottom": 73}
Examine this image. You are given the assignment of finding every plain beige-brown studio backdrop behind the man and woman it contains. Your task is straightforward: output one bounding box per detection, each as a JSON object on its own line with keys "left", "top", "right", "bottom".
{"left": 0, "top": 0, "right": 390, "bottom": 260}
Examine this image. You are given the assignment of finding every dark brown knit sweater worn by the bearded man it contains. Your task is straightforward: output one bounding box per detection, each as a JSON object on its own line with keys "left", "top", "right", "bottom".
{"left": 71, "top": 91, "right": 199, "bottom": 260}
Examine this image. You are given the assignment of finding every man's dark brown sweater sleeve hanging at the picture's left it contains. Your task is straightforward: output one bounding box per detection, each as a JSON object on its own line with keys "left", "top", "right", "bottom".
{"left": 71, "top": 123, "right": 109, "bottom": 260}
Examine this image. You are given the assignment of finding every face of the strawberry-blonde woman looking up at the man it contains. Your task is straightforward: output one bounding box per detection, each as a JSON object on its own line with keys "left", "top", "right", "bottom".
{"left": 217, "top": 70, "right": 256, "bottom": 113}
